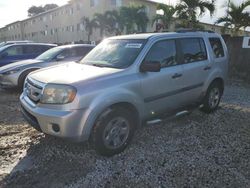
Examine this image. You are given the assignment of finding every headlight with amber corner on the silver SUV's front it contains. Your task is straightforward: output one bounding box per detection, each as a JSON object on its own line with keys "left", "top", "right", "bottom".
{"left": 41, "top": 84, "right": 76, "bottom": 104}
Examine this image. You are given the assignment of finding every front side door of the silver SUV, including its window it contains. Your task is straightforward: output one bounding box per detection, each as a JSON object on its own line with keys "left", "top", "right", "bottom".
{"left": 140, "top": 40, "right": 186, "bottom": 118}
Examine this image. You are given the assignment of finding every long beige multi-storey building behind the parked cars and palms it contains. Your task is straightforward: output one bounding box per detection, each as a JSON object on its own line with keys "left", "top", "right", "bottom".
{"left": 0, "top": 0, "right": 157, "bottom": 43}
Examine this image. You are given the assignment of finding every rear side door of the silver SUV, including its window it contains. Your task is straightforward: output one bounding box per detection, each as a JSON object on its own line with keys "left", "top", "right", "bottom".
{"left": 178, "top": 38, "right": 211, "bottom": 105}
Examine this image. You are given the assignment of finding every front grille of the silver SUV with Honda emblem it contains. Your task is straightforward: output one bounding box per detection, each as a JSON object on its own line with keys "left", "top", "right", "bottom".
{"left": 24, "top": 79, "right": 43, "bottom": 103}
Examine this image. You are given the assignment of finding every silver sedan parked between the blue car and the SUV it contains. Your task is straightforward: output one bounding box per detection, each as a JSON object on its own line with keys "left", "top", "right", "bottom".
{"left": 0, "top": 44, "right": 95, "bottom": 88}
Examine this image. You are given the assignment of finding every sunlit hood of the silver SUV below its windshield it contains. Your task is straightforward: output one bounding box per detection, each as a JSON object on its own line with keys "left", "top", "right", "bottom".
{"left": 30, "top": 62, "right": 121, "bottom": 84}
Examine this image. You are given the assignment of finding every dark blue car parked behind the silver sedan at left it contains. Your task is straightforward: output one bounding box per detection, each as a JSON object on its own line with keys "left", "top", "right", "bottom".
{"left": 0, "top": 43, "right": 57, "bottom": 67}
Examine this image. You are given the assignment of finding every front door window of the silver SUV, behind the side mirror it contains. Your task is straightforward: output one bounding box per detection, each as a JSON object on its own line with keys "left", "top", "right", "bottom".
{"left": 145, "top": 40, "right": 178, "bottom": 67}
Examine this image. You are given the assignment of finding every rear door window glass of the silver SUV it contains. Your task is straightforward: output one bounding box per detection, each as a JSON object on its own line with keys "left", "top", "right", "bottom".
{"left": 180, "top": 38, "right": 207, "bottom": 64}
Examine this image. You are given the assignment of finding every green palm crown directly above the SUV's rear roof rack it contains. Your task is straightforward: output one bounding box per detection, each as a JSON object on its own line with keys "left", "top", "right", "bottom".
{"left": 176, "top": 0, "right": 215, "bottom": 28}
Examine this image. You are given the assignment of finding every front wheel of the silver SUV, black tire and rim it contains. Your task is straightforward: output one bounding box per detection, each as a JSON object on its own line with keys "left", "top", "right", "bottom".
{"left": 92, "top": 107, "right": 135, "bottom": 157}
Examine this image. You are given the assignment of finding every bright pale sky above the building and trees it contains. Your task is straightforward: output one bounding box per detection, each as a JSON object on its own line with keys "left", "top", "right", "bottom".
{"left": 0, "top": 0, "right": 249, "bottom": 27}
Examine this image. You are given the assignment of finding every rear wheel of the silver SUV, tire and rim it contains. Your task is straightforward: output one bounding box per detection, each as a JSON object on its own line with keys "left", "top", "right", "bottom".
{"left": 201, "top": 82, "right": 223, "bottom": 113}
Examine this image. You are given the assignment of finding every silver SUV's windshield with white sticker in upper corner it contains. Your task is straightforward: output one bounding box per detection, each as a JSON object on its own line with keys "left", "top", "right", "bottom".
{"left": 80, "top": 39, "right": 146, "bottom": 69}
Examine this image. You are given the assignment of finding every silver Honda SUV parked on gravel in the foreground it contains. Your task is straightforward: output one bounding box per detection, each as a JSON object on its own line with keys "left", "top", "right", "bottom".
{"left": 20, "top": 32, "right": 228, "bottom": 156}
